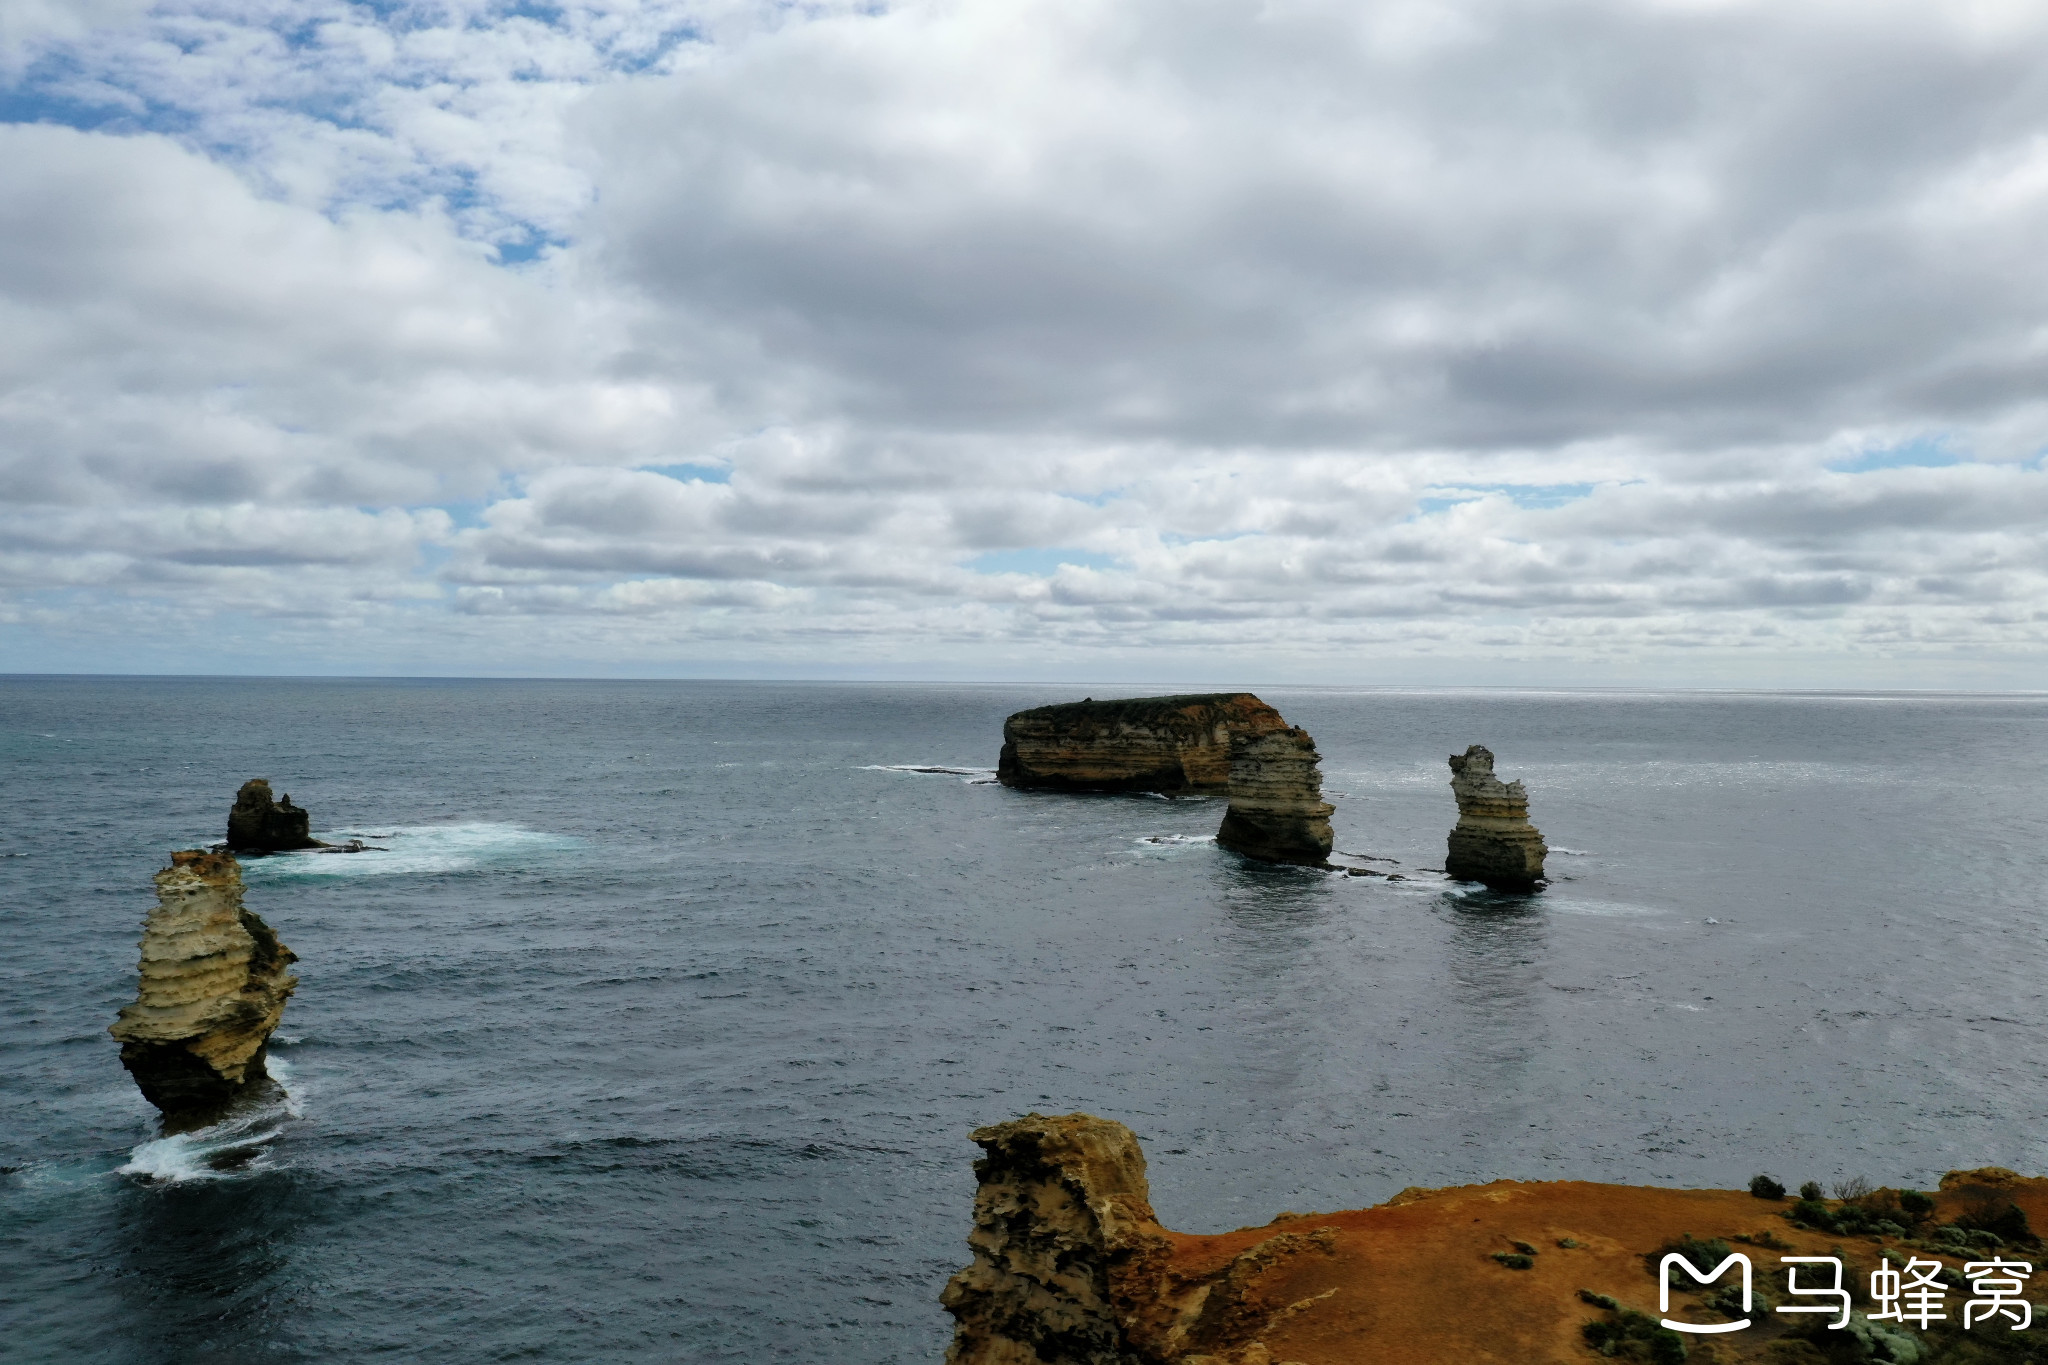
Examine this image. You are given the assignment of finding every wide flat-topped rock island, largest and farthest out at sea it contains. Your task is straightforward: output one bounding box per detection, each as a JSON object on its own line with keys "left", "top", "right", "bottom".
{"left": 995, "top": 692, "right": 1286, "bottom": 792}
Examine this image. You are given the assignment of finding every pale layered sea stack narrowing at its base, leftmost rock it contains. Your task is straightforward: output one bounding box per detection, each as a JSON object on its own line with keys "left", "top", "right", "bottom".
{"left": 109, "top": 849, "right": 299, "bottom": 1126}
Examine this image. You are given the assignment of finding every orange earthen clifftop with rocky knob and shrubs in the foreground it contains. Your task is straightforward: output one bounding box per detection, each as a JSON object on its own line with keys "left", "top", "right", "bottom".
{"left": 942, "top": 1113, "right": 2048, "bottom": 1365}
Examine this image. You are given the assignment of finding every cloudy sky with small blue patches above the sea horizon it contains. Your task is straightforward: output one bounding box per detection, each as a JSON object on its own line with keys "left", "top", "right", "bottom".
{"left": 0, "top": 0, "right": 2048, "bottom": 690}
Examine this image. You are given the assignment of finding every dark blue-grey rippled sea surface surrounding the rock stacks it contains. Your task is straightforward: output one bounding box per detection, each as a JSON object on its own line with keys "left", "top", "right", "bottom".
{"left": 0, "top": 677, "right": 2048, "bottom": 1365}
